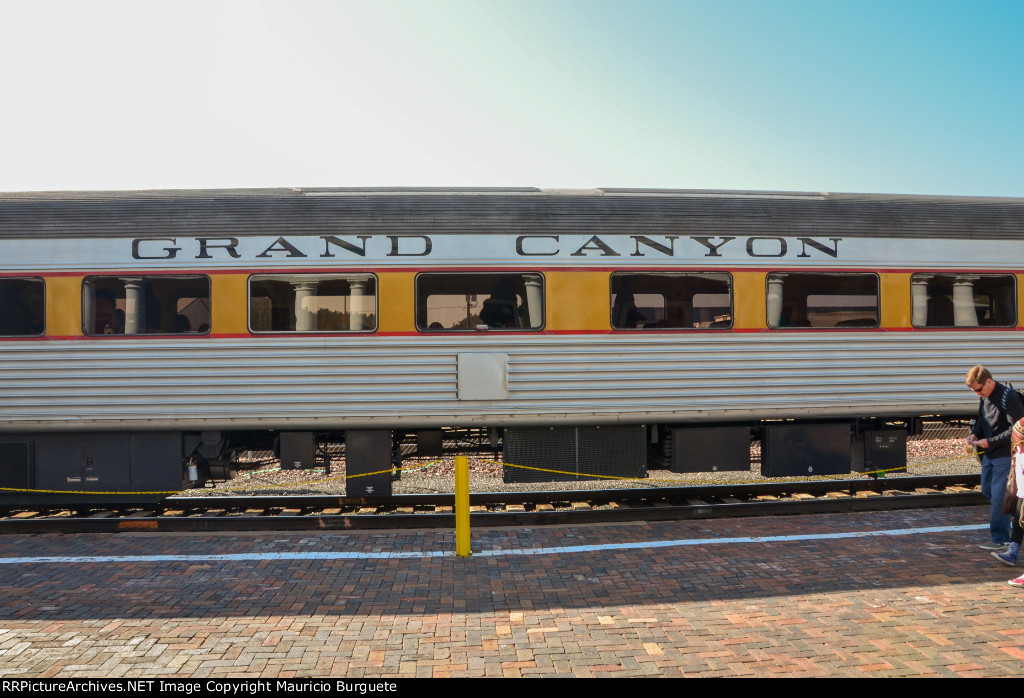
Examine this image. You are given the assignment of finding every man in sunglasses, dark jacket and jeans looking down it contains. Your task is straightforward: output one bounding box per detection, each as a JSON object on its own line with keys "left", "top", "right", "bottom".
{"left": 966, "top": 365, "right": 1024, "bottom": 551}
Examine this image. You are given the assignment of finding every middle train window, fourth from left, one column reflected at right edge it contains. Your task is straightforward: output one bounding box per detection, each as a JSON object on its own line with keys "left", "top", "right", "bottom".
{"left": 416, "top": 273, "right": 544, "bottom": 332}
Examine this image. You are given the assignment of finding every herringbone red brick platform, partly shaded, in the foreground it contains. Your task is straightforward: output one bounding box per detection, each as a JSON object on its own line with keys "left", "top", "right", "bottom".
{"left": 0, "top": 508, "right": 1024, "bottom": 678}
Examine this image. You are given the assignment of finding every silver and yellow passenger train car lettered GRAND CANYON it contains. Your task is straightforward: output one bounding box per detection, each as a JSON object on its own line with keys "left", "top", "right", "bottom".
{"left": 0, "top": 188, "right": 1024, "bottom": 500}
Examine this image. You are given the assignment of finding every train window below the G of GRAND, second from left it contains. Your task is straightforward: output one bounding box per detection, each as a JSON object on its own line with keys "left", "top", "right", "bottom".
{"left": 82, "top": 276, "right": 210, "bottom": 336}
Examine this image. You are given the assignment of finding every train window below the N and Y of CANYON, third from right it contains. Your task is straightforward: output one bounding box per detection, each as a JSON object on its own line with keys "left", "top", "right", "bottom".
{"left": 611, "top": 272, "right": 732, "bottom": 330}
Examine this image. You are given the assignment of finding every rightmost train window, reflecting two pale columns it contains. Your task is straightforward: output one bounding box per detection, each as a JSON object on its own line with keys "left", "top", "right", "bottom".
{"left": 910, "top": 273, "right": 1017, "bottom": 328}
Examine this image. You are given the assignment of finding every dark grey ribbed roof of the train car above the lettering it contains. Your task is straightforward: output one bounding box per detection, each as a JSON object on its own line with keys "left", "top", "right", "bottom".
{"left": 0, "top": 187, "right": 1024, "bottom": 239}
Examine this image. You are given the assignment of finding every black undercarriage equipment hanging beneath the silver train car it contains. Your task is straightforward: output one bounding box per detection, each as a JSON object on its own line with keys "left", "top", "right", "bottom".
{"left": 0, "top": 418, "right": 946, "bottom": 504}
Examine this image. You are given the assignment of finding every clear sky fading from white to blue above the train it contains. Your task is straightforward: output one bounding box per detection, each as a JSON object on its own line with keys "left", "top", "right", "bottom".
{"left": 0, "top": 0, "right": 1024, "bottom": 197}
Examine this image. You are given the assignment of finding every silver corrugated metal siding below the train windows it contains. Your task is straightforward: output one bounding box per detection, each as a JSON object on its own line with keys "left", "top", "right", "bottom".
{"left": 0, "top": 332, "right": 1007, "bottom": 431}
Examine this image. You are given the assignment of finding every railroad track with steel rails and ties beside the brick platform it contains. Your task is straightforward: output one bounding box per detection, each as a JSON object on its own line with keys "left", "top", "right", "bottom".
{"left": 0, "top": 474, "right": 984, "bottom": 533}
